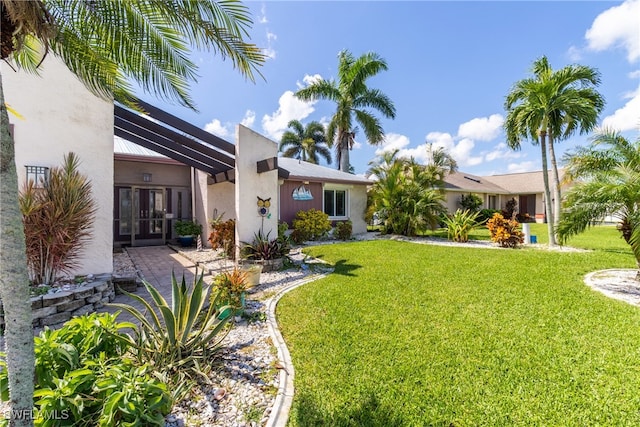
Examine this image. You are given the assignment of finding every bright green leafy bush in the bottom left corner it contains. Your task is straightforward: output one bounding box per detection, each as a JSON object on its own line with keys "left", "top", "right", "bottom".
{"left": 0, "top": 313, "right": 173, "bottom": 427}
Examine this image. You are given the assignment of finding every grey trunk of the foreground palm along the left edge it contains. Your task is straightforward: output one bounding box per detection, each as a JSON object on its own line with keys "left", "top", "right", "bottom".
{"left": 0, "top": 75, "right": 35, "bottom": 426}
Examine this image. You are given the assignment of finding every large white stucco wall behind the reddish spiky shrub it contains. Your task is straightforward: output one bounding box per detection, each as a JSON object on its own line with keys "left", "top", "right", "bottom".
{"left": 0, "top": 54, "right": 113, "bottom": 274}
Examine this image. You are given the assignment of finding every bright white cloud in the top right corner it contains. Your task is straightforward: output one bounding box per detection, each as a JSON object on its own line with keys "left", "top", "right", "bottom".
{"left": 585, "top": 0, "right": 640, "bottom": 62}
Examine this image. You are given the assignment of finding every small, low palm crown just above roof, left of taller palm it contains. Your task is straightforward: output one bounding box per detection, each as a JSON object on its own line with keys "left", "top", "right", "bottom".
{"left": 280, "top": 120, "right": 331, "bottom": 164}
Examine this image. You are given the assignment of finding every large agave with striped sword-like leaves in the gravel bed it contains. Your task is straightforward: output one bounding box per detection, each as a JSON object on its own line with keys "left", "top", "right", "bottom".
{"left": 110, "top": 271, "right": 230, "bottom": 399}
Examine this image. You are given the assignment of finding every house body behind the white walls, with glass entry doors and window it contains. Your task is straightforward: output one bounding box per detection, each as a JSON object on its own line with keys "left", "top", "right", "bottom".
{"left": 114, "top": 137, "right": 371, "bottom": 245}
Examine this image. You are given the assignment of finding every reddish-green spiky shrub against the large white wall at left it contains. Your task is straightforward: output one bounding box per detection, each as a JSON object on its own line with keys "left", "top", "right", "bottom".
{"left": 19, "top": 152, "right": 96, "bottom": 285}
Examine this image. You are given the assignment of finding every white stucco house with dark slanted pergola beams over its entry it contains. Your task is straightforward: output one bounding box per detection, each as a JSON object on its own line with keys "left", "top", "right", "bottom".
{"left": 0, "top": 55, "right": 368, "bottom": 275}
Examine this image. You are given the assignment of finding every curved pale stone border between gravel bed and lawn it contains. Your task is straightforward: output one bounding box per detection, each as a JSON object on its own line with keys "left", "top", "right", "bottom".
{"left": 266, "top": 272, "right": 331, "bottom": 427}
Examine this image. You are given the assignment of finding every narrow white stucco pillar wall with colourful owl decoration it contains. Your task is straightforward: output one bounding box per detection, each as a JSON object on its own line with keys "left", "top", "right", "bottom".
{"left": 235, "top": 125, "right": 280, "bottom": 258}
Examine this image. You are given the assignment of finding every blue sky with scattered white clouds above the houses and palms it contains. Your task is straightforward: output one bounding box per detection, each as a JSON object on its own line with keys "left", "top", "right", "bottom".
{"left": 136, "top": 0, "right": 640, "bottom": 175}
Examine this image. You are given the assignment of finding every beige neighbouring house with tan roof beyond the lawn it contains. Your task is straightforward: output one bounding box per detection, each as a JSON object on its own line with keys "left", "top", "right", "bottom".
{"left": 445, "top": 170, "right": 563, "bottom": 222}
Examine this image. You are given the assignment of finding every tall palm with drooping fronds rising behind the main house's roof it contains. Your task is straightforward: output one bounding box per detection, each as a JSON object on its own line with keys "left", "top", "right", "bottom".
{"left": 296, "top": 50, "right": 396, "bottom": 172}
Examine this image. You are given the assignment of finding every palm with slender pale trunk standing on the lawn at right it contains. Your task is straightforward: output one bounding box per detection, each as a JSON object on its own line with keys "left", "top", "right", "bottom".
{"left": 504, "top": 56, "right": 604, "bottom": 246}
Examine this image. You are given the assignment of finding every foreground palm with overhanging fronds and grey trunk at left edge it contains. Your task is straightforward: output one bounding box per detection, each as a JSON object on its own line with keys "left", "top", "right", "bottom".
{"left": 0, "top": 0, "right": 265, "bottom": 426}
